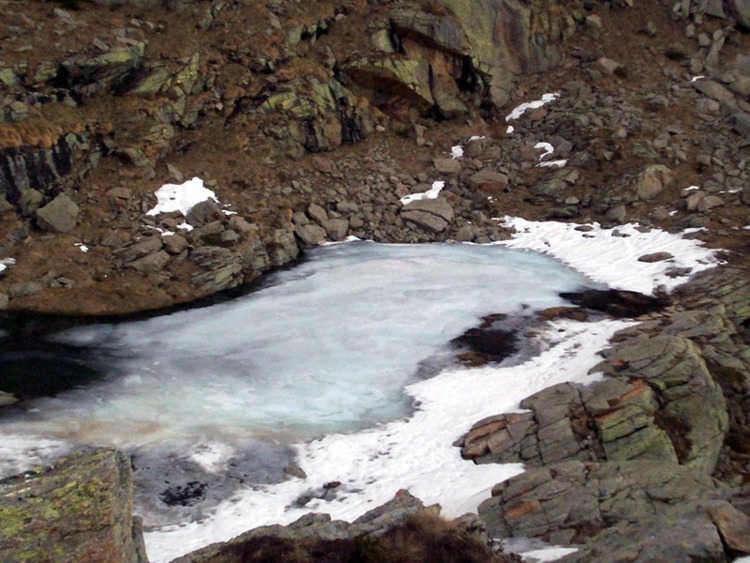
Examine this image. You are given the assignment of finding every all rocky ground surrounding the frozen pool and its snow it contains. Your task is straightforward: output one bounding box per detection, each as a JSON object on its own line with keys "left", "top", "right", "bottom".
{"left": 0, "top": 0, "right": 750, "bottom": 561}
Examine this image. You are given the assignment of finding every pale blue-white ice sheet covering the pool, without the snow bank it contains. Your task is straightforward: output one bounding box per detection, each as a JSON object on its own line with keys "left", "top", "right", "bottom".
{"left": 2, "top": 242, "right": 592, "bottom": 446}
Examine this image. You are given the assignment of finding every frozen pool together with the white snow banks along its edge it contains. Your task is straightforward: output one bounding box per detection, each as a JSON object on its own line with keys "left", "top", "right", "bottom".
{"left": 0, "top": 222, "right": 714, "bottom": 561}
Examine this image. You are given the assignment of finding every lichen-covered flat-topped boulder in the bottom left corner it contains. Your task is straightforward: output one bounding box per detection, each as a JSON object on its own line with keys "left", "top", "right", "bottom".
{"left": 0, "top": 449, "right": 147, "bottom": 563}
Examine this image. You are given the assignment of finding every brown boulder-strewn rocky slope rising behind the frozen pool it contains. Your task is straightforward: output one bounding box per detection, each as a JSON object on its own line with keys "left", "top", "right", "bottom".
{"left": 0, "top": 0, "right": 750, "bottom": 314}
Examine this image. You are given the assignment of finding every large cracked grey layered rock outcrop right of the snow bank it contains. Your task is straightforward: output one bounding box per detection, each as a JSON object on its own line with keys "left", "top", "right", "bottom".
{"left": 459, "top": 269, "right": 750, "bottom": 561}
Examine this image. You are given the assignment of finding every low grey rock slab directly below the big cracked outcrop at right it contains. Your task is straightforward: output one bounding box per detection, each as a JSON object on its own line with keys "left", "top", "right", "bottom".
{"left": 479, "top": 461, "right": 720, "bottom": 546}
